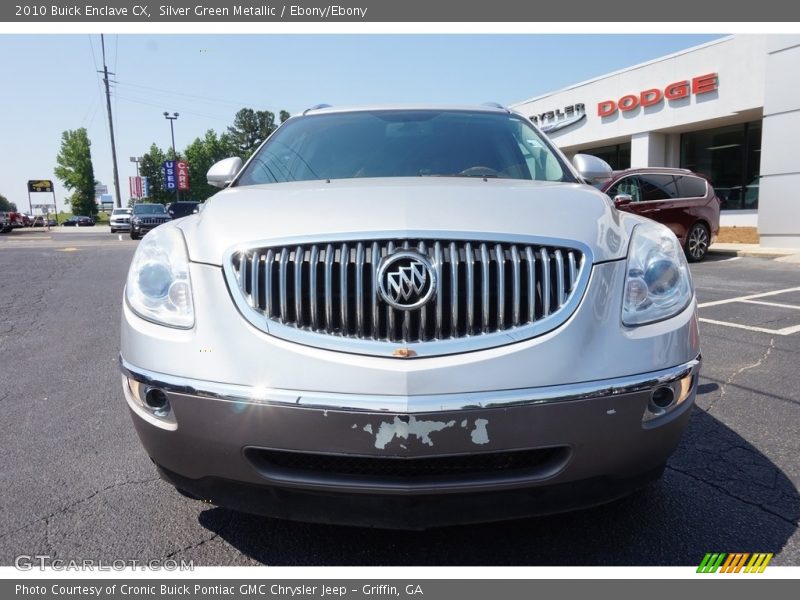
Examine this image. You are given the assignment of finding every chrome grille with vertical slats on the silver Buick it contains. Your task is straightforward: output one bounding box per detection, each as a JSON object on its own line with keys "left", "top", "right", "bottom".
{"left": 226, "top": 239, "right": 588, "bottom": 354}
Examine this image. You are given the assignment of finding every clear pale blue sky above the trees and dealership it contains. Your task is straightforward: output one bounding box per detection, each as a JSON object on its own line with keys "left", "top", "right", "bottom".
{"left": 0, "top": 34, "right": 720, "bottom": 210}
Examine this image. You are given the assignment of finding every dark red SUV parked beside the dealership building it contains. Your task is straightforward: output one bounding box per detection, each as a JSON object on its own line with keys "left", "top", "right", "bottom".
{"left": 600, "top": 167, "right": 720, "bottom": 262}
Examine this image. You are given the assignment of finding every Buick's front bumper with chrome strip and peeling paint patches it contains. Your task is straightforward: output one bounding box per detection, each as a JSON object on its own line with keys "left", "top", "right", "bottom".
{"left": 122, "top": 356, "right": 700, "bottom": 528}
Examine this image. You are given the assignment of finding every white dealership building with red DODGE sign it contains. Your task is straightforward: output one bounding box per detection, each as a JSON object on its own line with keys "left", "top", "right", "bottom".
{"left": 512, "top": 35, "right": 800, "bottom": 248}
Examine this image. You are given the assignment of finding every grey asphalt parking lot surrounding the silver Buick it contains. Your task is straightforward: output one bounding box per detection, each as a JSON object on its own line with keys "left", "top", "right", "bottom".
{"left": 0, "top": 230, "right": 800, "bottom": 566}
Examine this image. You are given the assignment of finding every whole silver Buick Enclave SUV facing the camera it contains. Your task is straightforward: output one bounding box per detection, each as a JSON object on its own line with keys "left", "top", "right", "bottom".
{"left": 120, "top": 106, "right": 700, "bottom": 529}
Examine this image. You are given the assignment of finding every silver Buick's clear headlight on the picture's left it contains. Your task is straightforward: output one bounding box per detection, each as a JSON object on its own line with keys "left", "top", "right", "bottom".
{"left": 125, "top": 227, "right": 194, "bottom": 329}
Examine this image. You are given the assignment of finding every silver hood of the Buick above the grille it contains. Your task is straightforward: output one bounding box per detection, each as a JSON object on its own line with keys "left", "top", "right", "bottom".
{"left": 180, "top": 177, "right": 632, "bottom": 265}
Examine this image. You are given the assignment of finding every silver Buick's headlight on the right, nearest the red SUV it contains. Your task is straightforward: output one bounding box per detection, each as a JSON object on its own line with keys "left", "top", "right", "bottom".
{"left": 622, "top": 222, "right": 693, "bottom": 325}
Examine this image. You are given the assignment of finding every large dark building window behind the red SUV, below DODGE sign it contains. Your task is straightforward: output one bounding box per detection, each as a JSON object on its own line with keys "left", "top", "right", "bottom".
{"left": 681, "top": 121, "right": 761, "bottom": 210}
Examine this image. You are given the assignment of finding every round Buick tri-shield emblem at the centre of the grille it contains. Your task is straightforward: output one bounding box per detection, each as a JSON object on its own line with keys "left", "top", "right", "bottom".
{"left": 378, "top": 250, "right": 436, "bottom": 310}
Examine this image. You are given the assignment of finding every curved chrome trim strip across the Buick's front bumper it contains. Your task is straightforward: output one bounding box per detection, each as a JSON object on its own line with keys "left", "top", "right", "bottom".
{"left": 119, "top": 355, "right": 701, "bottom": 413}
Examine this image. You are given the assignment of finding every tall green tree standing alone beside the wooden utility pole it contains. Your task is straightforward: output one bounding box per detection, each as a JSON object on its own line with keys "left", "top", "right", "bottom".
{"left": 55, "top": 127, "right": 97, "bottom": 215}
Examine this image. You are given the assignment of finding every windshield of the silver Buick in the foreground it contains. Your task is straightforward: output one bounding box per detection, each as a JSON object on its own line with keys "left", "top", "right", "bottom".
{"left": 234, "top": 110, "right": 574, "bottom": 185}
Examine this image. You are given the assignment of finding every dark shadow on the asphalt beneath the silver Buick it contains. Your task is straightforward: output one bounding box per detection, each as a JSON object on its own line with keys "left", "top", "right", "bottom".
{"left": 199, "top": 406, "right": 800, "bottom": 566}
